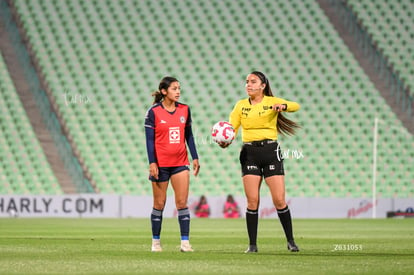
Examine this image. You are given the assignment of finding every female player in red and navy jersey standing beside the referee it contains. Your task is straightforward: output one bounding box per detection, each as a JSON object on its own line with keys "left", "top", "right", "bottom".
{"left": 145, "top": 76, "right": 200, "bottom": 252}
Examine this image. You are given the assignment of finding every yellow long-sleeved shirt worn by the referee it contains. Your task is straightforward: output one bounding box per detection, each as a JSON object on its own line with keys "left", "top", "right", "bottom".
{"left": 229, "top": 96, "right": 300, "bottom": 142}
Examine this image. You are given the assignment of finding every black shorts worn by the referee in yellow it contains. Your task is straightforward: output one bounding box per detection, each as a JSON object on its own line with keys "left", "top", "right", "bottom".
{"left": 240, "top": 140, "right": 285, "bottom": 178}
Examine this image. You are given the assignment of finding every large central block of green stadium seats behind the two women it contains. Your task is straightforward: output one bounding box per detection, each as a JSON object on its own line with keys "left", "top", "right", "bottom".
{"left": 6, "top": 0, "right": 413, "bottom": 197}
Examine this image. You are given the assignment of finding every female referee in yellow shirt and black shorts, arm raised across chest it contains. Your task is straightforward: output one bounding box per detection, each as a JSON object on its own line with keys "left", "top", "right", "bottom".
{"left": 219, "top": 71, "right": 300, "bottom": 253}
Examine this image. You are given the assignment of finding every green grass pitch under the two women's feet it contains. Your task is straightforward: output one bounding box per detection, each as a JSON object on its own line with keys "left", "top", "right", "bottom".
{"left": 0, "top": 218, "right": 414, "bottom": 275}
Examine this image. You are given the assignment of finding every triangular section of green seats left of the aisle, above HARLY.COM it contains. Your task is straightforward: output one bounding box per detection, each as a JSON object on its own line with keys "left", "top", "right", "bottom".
{"left": 0, "top": 55, "right": 62, "bottom": 194}
